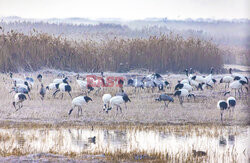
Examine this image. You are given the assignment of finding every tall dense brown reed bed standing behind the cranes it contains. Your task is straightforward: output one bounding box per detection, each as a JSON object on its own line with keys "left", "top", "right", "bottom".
{"left": 0, "top": 31, "right": 223, "bottom": 72}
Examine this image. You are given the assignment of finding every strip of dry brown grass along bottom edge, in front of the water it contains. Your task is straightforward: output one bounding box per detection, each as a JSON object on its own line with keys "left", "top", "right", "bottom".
{"left": 0, "top": 149, "right": 209, "bottom": 162}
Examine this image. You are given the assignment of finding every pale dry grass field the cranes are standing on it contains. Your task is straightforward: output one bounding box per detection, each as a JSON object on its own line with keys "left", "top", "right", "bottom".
{"left": 0, "top": 70, "right": 250, "bottom": 126}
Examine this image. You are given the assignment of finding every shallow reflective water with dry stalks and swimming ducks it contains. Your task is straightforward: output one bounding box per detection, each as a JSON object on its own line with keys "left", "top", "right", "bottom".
{"left": 0, "top": 126, "right": 250, "bottom": 162}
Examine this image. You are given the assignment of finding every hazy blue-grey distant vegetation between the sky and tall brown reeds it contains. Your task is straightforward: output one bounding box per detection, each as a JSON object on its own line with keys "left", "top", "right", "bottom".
{"left": 0, "top": 18, "right": 250, "bottom": 47}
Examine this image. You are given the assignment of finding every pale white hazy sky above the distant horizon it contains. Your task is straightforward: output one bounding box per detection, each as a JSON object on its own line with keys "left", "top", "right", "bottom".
{"left": 0, "top": 0, "right": 250, "bottom": 19}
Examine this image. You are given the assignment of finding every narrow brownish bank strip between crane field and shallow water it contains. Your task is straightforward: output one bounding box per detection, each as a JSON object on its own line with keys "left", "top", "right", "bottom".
{"left": 0, "top": 119, "right": 250, "bottom": 128}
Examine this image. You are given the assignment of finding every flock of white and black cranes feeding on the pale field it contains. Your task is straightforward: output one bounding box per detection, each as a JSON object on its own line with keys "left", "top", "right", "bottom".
{"left": 5, "top": 67, "right": 248, "bottom": 121}
